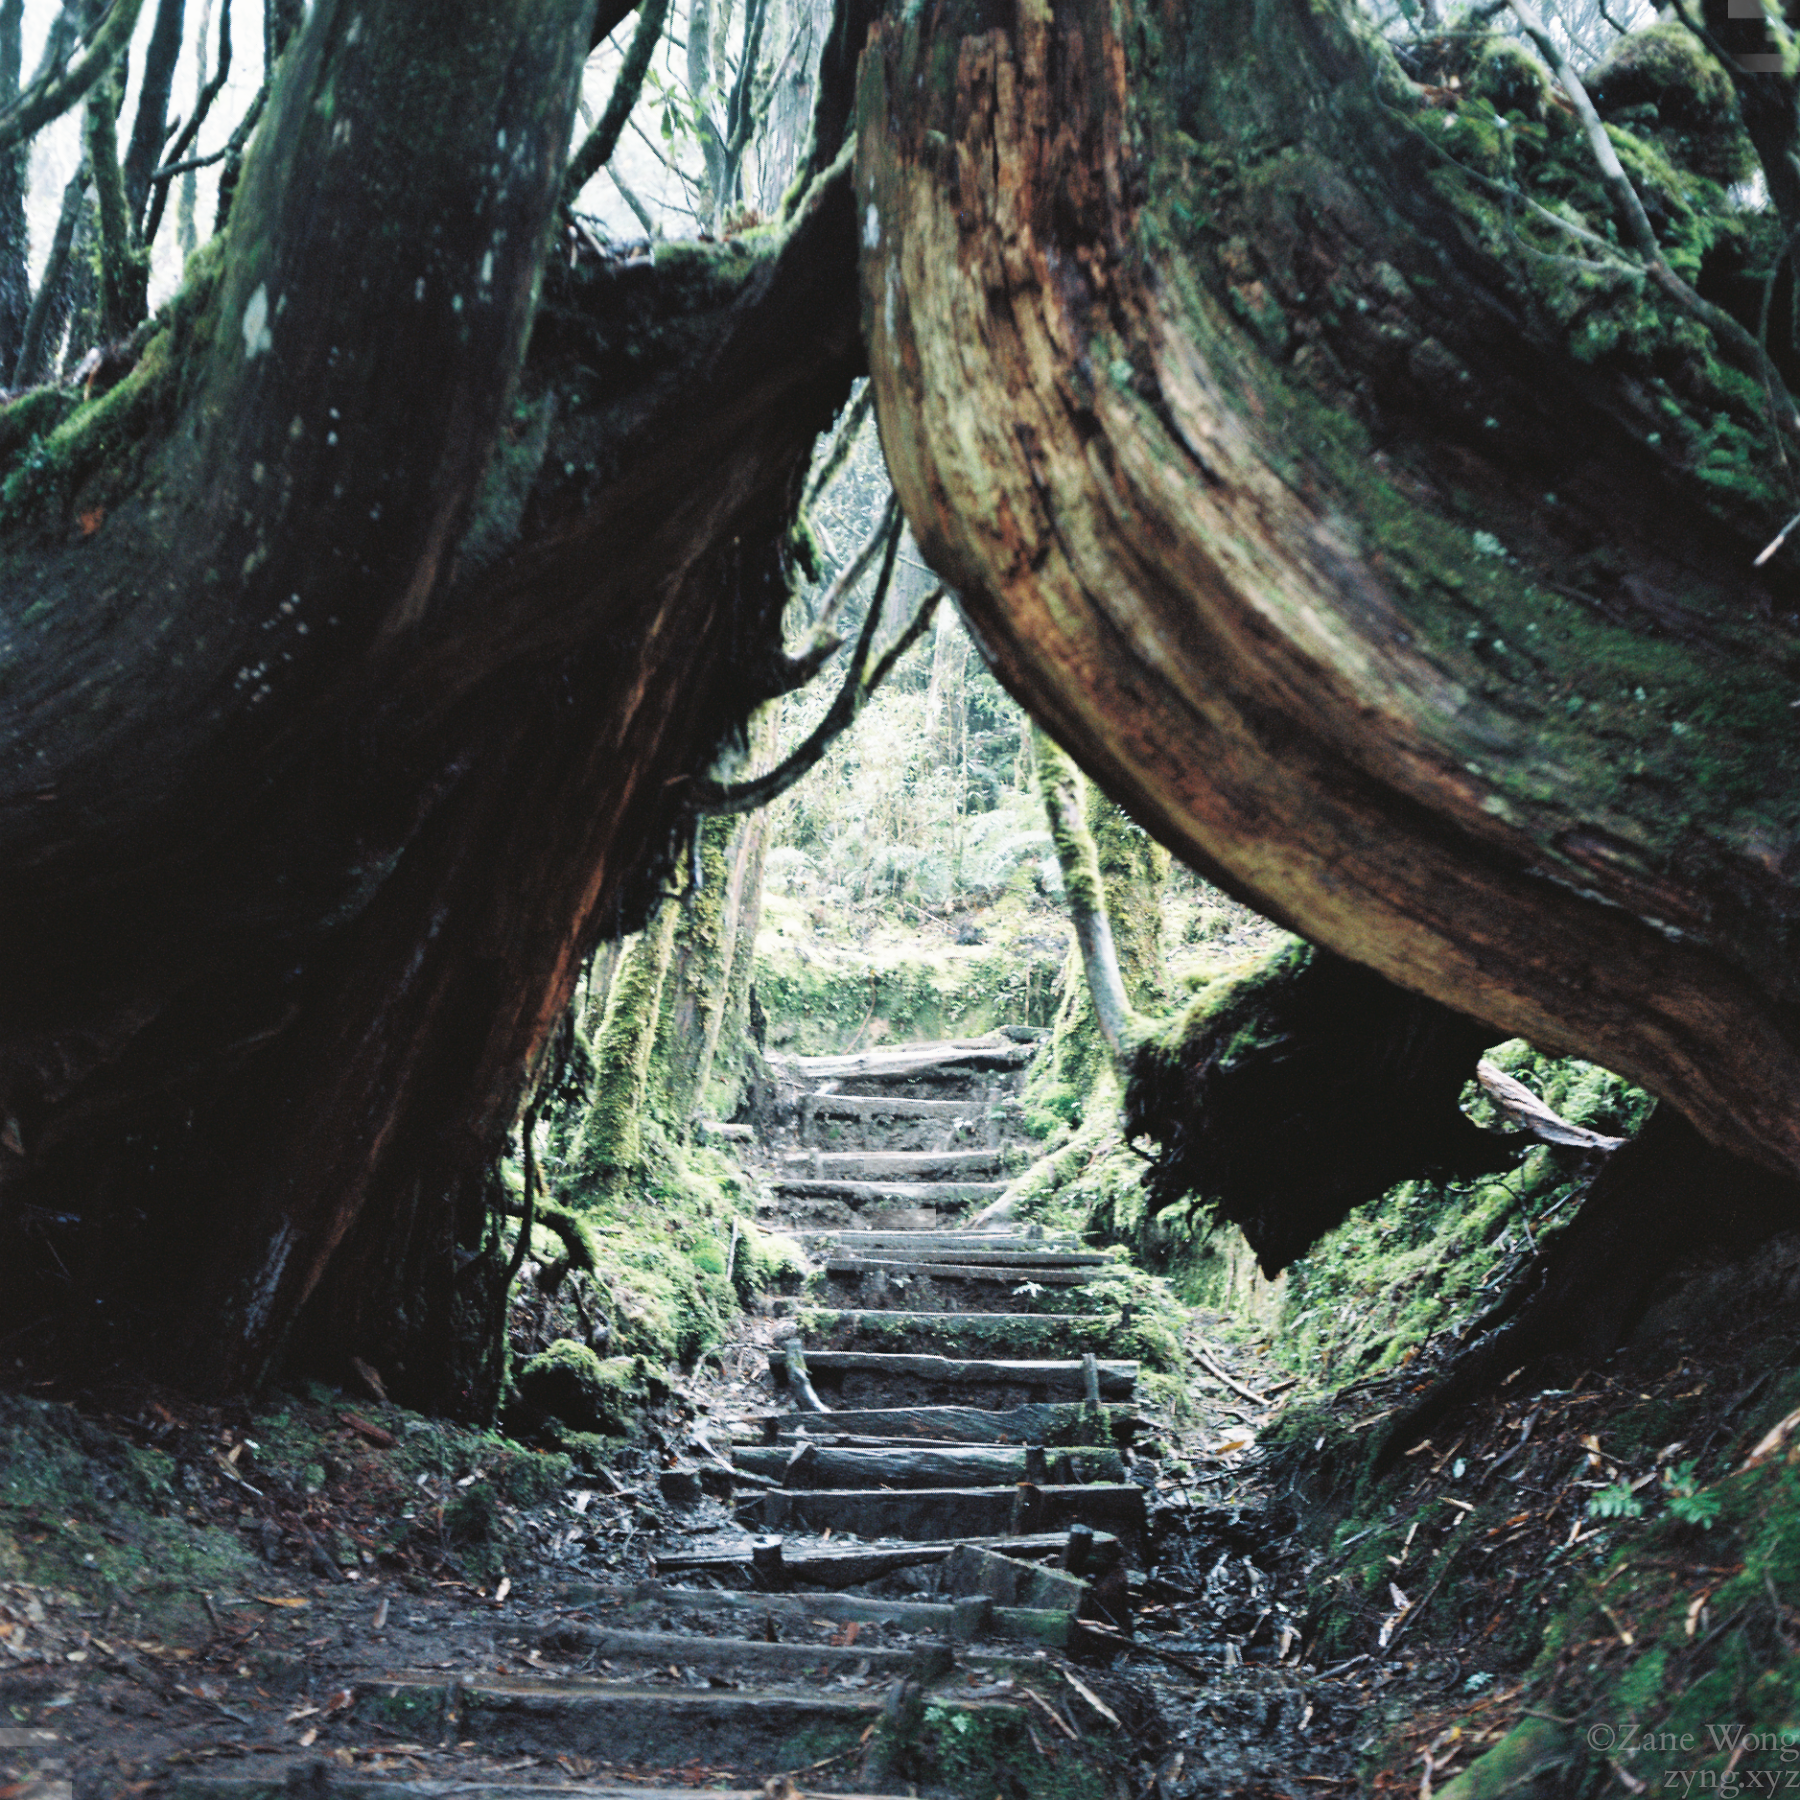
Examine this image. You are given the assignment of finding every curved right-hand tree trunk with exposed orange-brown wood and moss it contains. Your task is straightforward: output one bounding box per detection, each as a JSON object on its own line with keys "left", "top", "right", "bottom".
{"left": 857, "top": 0, "right": 1800, "bottom": 1172}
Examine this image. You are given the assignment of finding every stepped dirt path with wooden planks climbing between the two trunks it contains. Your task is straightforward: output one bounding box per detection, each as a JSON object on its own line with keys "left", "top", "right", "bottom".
{"left": 0, "top": 1042, "right": 1357, "bottom": 1800}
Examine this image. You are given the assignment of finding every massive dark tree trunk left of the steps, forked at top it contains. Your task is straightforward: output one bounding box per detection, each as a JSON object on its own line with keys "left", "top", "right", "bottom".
{"left": 0, "top": 0, "right": 860, "bottom": 1411}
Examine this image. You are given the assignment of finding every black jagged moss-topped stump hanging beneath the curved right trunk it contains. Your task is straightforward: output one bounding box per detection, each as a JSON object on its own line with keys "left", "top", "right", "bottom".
{"left": 1125, "top": 943, "right": 1530, "bottom": 1274}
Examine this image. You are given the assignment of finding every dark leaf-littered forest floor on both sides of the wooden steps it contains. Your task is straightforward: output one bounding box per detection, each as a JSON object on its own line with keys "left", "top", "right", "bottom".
{"left": 0, "top": 1267, "right": 1800, "bottom": 1800}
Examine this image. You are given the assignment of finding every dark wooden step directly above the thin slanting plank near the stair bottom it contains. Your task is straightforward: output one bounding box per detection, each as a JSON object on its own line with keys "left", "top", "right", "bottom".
{"left": 736, "top": 1481, "right": 1148, "bottom": 1539}
